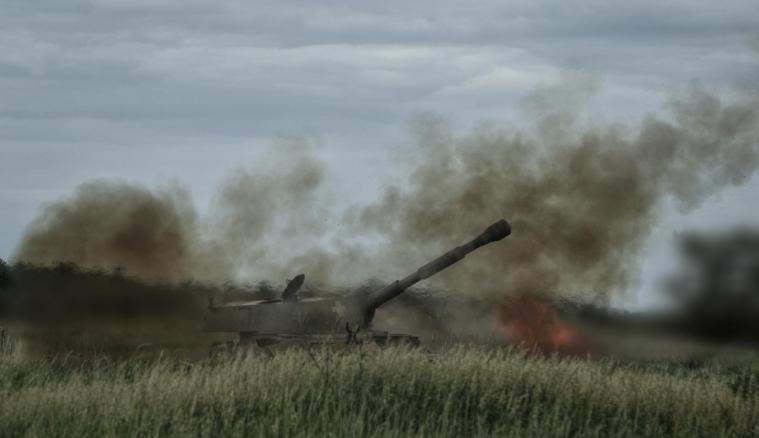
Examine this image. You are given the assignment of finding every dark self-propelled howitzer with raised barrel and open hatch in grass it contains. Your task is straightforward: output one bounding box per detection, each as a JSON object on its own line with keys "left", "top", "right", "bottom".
{"left": 206, "top": 220, "right": 511, "bottom": 345}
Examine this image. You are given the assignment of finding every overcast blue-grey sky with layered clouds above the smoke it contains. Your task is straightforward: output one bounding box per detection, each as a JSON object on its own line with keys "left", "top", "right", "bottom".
{"left": 0, "top": 0, "right": 759, "bottom": 308}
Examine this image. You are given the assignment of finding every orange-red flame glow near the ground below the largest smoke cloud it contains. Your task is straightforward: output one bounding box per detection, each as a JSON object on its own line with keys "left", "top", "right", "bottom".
{"left": 499, "top": 294, "right": 590, "bottom": 356}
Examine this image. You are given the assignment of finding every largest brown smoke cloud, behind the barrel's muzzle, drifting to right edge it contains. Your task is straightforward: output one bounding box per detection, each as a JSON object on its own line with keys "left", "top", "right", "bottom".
{"left": 357, "top": 82, "right": 759, "bottom": 300}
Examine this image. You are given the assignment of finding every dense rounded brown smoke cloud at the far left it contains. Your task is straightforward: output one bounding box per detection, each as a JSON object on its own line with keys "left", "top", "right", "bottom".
{"left": 15, "top": 180, "right": 198, "bottom": 281}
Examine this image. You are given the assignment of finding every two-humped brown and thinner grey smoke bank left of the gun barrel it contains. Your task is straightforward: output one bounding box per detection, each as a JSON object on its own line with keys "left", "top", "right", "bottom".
{"left": 14, "top": 139, "right": 336, "bottom": 283}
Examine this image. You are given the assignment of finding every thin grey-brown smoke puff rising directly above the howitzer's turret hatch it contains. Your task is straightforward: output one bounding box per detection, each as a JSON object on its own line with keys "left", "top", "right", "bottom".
{"left": 198, "top": 138, "right": 332, "bottom": 281}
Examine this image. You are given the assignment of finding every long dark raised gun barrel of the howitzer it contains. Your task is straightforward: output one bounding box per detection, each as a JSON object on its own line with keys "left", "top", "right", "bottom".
{"left": 366, "top": 219, "right": 511, "bottom": 315}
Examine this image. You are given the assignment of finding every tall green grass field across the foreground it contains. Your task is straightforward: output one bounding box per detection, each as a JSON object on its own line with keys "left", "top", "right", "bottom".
{"left": 0, "top": 346, "right": 759, "bottom": 437}
